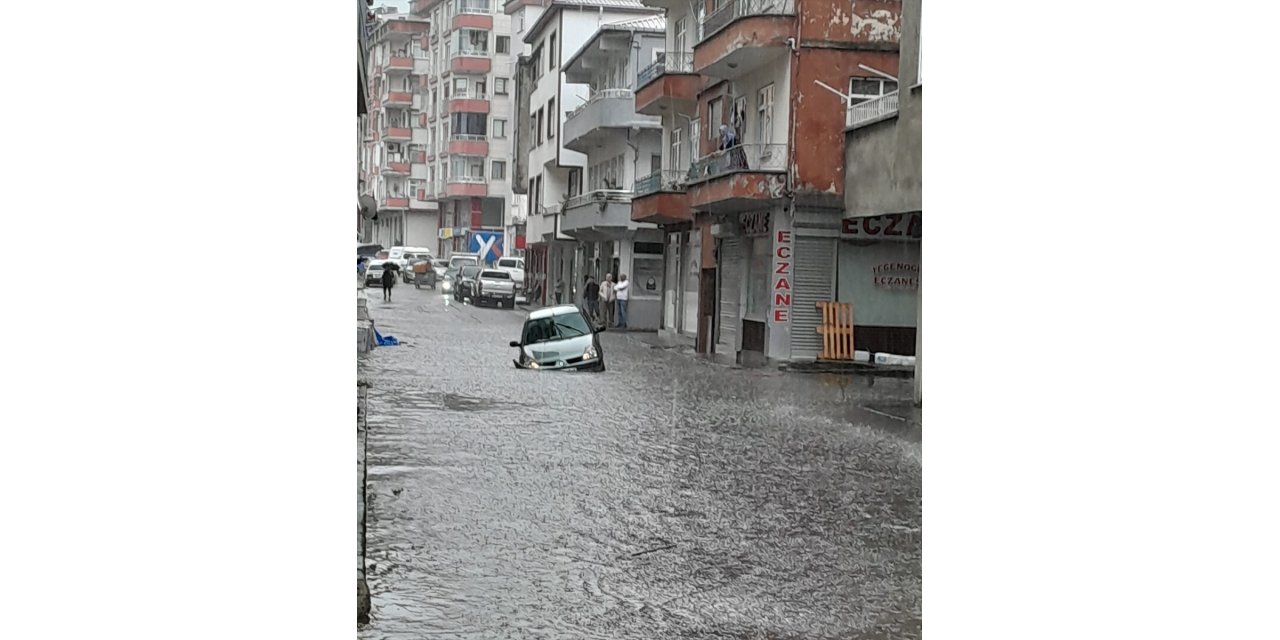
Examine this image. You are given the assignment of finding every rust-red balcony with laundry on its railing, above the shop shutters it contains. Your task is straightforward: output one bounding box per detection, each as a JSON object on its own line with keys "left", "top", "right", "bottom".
{"left": 686, "top": 143, "right": 790, "bottom": 214}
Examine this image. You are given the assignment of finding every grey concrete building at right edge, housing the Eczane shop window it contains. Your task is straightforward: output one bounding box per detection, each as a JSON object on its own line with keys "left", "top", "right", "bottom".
{"left": 837, "top": 0, "right": 924, "bottom": 402}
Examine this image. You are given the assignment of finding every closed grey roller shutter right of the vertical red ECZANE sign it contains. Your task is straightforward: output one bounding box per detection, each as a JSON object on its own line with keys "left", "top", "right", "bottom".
{"left": 791, "top": 236, "right": 836, "bottom": 360}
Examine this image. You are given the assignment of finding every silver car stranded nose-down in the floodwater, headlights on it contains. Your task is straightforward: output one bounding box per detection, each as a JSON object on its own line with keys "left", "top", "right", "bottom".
{"left": 511, "top": 305, "right": 604, "bottom": 371}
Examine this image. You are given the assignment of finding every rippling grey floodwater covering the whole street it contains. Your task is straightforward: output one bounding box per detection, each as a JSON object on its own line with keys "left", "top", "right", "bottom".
{"left": 360, "top": 285, "right": 922, "bottom": 639}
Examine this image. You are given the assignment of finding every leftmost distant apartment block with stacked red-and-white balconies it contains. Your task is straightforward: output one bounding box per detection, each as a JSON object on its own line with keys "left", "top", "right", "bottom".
{"left": 362, "top": 8, "right": 440, "bottom": 247}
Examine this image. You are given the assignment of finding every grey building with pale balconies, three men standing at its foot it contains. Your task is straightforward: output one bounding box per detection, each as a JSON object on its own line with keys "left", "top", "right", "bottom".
{"left": 561, "top": 15, "right": 666, "bottom": 330}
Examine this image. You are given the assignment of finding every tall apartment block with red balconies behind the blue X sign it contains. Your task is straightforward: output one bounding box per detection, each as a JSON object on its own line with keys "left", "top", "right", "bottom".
{"left": 412, "top": 0, "right": 518, "bottom": 261}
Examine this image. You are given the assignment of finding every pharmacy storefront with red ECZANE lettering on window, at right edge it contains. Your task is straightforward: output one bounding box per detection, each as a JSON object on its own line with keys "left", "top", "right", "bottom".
{"left": 837, "top": 212, "right": 920, "bottom": 356}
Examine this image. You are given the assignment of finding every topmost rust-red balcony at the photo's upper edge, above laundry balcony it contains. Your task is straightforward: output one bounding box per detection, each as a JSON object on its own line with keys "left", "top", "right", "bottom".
{"left": 694, "top": 0, "right": 796, "bottom": 79}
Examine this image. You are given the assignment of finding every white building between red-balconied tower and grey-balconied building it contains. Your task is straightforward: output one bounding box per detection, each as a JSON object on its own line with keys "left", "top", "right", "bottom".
{"left": 504, "top": 0, "right": 655, "bottom": 303}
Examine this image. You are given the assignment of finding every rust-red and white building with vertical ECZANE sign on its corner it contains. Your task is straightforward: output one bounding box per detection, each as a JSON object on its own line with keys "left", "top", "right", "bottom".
{"left": 632, "top": 0, "right": 901, "bottom": 361}
